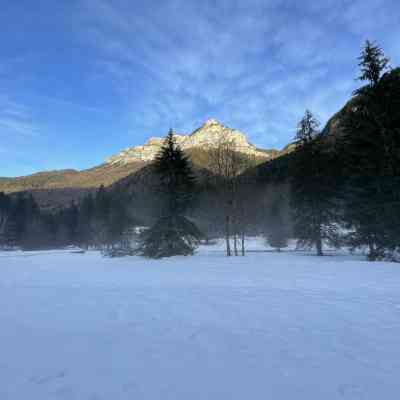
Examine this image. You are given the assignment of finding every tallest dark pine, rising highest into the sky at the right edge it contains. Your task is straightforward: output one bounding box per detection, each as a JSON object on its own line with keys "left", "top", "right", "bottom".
{"left": 337, "top": 42, "right": 400, "bottom": 260}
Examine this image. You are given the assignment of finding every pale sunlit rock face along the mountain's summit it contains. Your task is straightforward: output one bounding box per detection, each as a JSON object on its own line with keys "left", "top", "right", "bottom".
{"left": 106, "top": 119, "right": 274, "bottom": 164}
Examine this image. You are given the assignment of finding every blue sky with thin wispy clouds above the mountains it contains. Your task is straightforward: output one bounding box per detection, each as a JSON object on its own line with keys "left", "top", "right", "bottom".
{"left": 0, "top": 0, "right": 400, "bottom": 176}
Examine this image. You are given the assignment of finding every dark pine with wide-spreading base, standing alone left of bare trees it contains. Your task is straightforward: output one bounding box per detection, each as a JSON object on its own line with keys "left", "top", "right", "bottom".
{"left": 139, "top": 131, "right": 201, "bottom": 258}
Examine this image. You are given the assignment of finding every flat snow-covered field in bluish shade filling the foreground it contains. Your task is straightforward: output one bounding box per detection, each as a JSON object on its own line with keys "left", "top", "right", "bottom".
{"left": 0, "top": 242, "right": 400, "bottom": 400}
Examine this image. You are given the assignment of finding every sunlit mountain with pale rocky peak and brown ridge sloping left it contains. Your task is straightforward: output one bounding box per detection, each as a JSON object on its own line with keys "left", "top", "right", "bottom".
{"left": 0, "top": 119, "right": 280, "bottom": 207}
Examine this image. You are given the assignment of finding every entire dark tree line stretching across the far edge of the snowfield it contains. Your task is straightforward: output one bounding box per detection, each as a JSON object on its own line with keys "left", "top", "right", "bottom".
{"left": 0, "top": 41, "right": 400, "bottom": 260}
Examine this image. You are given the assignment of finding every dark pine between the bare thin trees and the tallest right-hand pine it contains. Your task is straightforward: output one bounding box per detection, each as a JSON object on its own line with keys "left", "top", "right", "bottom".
{"left": 291, "top": 110, "right": 337, "bottom": 256}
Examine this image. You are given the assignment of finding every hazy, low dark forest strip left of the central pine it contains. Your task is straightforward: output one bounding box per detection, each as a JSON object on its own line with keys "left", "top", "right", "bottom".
{"left": 0, "top": 186, "right": 136, "bottom": 250}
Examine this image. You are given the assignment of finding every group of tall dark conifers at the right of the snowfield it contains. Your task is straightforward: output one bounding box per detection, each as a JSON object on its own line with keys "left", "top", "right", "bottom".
{"left": 290, "top": 41, "right": 400, "bottom": 260}
